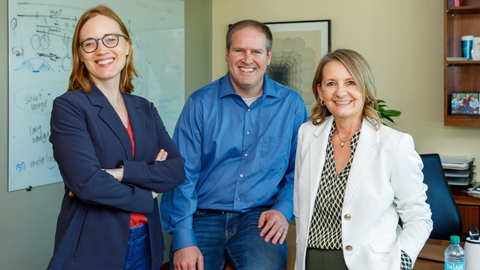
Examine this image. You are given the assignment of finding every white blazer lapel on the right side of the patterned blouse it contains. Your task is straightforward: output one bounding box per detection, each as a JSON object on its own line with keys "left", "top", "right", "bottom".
{"left": 343, "top": 119, "right": 381, "bottom": 207}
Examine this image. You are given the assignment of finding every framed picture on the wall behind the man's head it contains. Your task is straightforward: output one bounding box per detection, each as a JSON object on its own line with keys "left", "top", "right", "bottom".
{"left": 265, "top": 20, "right": 331, "bottom": 110}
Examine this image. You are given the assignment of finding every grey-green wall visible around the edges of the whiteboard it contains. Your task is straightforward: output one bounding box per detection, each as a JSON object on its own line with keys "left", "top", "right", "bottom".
{"left": 0, "top": 0, "right": 212, "bottom": 270}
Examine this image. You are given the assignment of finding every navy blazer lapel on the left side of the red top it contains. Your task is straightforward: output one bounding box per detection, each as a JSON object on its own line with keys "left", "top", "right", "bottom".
{"left": 87, "top": 83, "right": 132, "bottom": 160}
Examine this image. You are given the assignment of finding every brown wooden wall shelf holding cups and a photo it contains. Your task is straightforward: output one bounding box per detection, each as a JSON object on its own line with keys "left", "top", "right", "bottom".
{"left": 444, "top": 0, "right": 480, "bottom": 127}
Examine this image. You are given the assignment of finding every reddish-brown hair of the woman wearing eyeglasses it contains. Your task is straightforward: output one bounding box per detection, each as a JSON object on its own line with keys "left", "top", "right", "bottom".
{"left": 67, "top": 6, "right": 138, "bottom": 94}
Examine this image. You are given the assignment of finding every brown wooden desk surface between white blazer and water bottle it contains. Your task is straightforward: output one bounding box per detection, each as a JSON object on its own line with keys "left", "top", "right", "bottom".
{"left": 413, "top": 239, "right": 464, "bottom": 270}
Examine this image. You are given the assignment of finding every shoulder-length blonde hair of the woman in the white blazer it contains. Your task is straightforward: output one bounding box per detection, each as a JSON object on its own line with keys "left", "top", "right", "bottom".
{"left": 308, "top": 49, "right": 381, "bottom": 130}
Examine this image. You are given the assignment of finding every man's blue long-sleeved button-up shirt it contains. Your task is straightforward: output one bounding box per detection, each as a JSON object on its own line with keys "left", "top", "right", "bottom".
{"left": 161, "top": 73, "right": 307, "bottom": 250}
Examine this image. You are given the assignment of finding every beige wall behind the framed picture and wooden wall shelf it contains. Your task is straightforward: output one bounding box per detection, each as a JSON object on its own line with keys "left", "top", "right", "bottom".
{"left": 212, "top": 0, "right": 480, "bottom": 166}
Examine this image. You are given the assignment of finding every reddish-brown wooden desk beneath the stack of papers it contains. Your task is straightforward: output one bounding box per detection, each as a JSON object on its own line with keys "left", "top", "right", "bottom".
{"left": 451, "top": 187, "right": 480, "bottom": 238}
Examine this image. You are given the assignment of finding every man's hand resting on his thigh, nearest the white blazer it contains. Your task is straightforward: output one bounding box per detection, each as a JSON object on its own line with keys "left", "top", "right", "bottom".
{"left": 258, "top": 210, "right": 289, "bottom": 245}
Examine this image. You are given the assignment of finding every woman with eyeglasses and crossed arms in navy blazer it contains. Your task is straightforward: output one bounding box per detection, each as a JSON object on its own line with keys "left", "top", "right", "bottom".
{"left": 48, "top": 6, "right": 185, "bottom": 270}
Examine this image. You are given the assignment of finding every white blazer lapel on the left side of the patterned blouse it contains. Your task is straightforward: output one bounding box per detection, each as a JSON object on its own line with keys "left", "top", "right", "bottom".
{"left": 308, "top": 117, "right": 333, "bottom": 197}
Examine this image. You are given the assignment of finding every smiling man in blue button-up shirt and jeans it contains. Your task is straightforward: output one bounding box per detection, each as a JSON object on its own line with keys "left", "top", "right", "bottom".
{"left": 161, "top": 20, "right": 307, "bottom": 270}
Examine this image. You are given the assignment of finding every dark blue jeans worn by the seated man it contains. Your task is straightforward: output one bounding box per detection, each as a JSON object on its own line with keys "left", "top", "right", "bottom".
{"left": 170, "top": 208, "right": 287, "bottom": 270}
